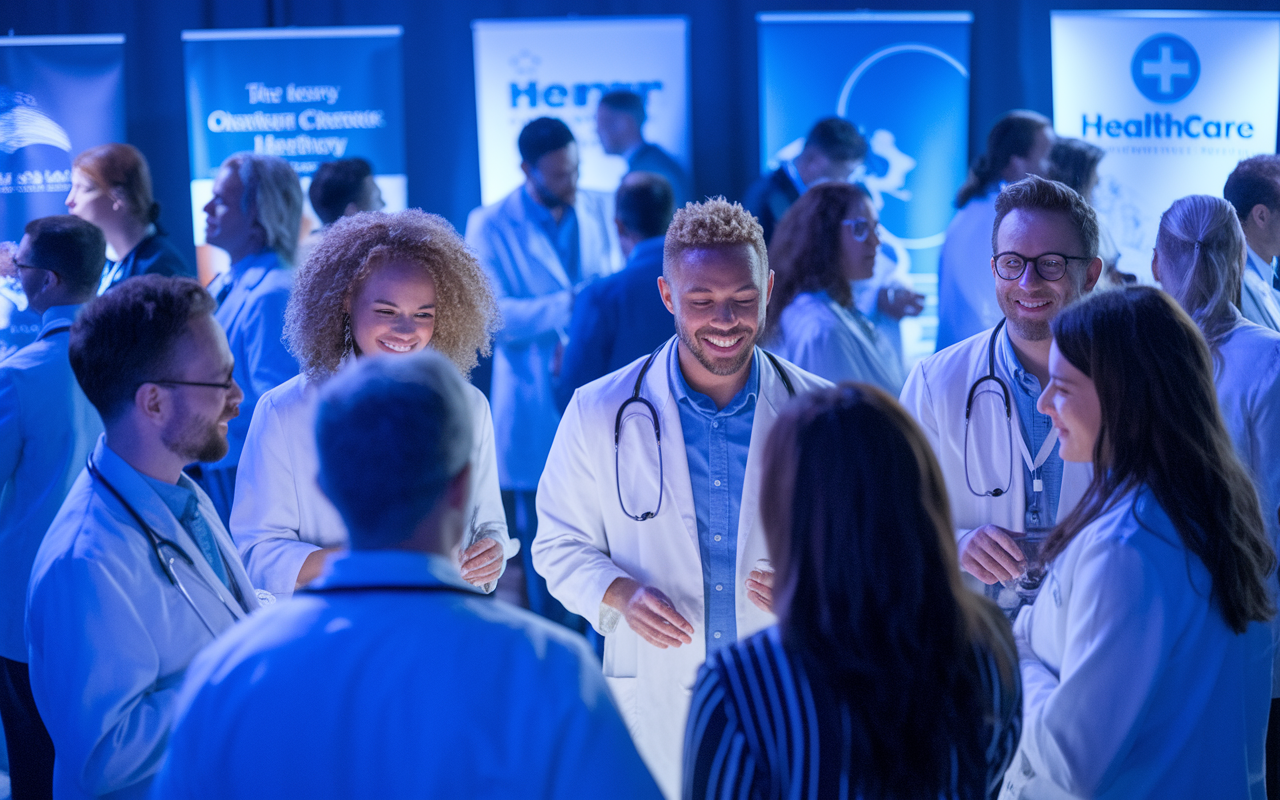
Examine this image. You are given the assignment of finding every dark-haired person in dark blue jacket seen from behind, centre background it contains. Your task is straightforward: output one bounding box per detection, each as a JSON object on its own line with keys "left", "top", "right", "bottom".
{"left": 556, "top": 172, "right": 676, "bottom": 413}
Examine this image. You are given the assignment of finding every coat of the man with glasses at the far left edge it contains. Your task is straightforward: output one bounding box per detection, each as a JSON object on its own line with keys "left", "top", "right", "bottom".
{"left": 0, "top": 306, "right": 102, "bottom": 663}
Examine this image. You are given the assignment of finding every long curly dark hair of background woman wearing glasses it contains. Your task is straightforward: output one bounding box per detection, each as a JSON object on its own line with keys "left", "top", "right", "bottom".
{"left": 769, "top": 183, "right": 870, "bottom": 335}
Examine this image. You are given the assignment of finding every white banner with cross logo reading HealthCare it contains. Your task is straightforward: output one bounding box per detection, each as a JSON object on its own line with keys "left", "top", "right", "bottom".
{"left": 1050, "top": 12, "right": 1280, "bottom": 283}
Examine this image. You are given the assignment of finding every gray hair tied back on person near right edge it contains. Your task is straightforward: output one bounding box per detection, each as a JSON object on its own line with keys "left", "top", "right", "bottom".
{"left": 1156, "top": 195, "right": 1244, "bottom": 353}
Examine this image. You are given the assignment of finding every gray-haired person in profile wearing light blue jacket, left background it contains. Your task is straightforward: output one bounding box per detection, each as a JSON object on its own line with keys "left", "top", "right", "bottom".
{"left": 200, "top": 152, "right": 302, "bottom": 525}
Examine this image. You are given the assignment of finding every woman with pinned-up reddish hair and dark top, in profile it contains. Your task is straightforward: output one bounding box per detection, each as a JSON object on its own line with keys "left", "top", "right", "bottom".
{"left": 65, "top": 142, "right": 196, "bottom": 294}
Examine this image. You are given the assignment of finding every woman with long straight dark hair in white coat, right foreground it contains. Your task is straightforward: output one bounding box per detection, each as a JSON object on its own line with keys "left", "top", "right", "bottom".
{"left": 1002, "top": 287, "right": 1276, "bottom": 800}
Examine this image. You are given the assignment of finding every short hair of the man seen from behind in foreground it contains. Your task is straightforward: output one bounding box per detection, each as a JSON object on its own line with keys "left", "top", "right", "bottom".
{"left": 315, "top": 349, "right": 474, "bottom": 550}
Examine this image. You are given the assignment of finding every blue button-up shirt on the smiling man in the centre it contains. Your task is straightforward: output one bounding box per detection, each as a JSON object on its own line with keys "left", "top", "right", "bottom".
{"left": 667, "top": 347, "right": 762, "bottom": 657}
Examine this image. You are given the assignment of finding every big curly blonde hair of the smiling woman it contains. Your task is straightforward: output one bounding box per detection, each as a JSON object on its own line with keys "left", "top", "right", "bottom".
{"left": 284, "top": 209, "right": 499, "bottom": 383}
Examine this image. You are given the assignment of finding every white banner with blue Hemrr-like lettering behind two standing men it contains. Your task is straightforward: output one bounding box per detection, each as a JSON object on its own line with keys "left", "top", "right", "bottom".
{"left": 471, "top": 17, "right": 691, "bottom": 205}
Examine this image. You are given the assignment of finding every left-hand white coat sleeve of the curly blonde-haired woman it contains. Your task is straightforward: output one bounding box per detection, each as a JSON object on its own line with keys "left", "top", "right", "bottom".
{"left": 230, "top": 394, "right": 320, "bottom": 596}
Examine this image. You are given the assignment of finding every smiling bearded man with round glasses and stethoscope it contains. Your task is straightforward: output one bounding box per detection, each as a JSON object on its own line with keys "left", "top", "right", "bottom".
{"left": 902, "top": 175, "right": 1102, "bottom": 617}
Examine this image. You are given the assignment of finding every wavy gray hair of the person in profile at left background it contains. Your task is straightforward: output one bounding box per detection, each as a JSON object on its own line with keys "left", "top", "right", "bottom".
{"left": 223, "top": 151, "right": 302, "bottom": 266}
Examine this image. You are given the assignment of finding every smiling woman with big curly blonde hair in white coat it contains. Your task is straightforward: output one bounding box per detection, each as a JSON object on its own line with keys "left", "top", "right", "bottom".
{"left": 230, "top": 209, "right": 515, "bottom": 596}
